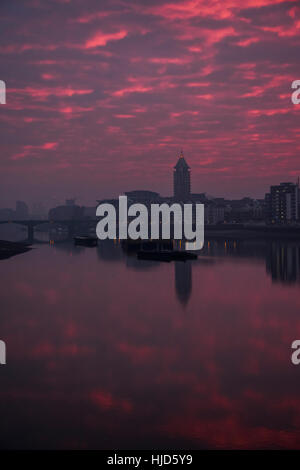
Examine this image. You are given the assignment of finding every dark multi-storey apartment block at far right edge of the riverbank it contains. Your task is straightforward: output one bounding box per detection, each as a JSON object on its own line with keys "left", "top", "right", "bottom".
{"left": 265, "top": 183, "right": 299, "bottom": 223}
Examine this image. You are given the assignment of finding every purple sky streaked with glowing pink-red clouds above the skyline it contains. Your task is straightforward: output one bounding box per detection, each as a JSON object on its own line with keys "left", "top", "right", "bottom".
{"left": 0, "top": 0, "right": 300, "bottom": 207}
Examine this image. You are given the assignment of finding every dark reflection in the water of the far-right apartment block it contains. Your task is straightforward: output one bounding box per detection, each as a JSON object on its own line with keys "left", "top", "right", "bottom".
{"left": 266, "top": 240, "right": 300, "bottom": 283}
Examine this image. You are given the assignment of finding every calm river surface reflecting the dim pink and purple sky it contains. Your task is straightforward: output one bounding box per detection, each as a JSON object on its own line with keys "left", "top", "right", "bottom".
{"left": 0, "top": 229, "right": 300, "bottom": 449}
